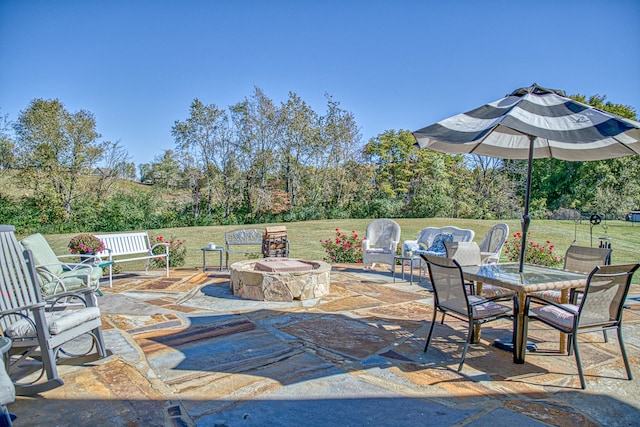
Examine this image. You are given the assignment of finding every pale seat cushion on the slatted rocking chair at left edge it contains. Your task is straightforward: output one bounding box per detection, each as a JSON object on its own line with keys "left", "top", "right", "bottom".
{"left": 5, "top": 307, "right": 100, "bottom": 338}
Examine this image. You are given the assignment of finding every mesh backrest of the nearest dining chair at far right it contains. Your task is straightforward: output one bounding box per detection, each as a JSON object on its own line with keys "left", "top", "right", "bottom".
{"left": 578, "top": 264, "right": 640, "bottom": 328}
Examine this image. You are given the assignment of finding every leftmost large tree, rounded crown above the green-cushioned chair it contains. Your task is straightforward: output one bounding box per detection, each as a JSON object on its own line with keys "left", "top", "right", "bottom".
{"left": 14, "top": 99, "right": 103, "bottom": 216}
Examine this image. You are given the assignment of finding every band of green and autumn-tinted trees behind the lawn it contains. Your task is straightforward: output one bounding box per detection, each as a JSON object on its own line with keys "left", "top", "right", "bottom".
{"left": 0, "top": 88, "right": 640, "bottom": 233}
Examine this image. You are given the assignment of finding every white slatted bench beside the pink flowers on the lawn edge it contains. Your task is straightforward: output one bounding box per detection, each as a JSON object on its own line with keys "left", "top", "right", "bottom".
{"left": 95, "top": 231, "right": 169, "bottom": 287}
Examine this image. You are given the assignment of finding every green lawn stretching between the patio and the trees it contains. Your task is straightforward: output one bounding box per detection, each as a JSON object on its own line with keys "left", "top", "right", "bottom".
{"left": 35, "top": 218, "right": 640, "bottom": 270}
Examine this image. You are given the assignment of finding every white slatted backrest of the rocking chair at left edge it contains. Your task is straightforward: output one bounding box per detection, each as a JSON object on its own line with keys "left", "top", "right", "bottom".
{"left": 0, "top": 225, "right": 41, "bottom": 331}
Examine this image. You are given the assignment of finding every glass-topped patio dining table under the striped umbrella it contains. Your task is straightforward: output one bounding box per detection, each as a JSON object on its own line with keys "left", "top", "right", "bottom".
{"left": 462, "top": 263, "right": 587, "bottom": 363}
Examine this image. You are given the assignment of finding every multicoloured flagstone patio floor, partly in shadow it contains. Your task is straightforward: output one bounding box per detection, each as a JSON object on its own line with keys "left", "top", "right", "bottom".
{"left": 9, "top": 265, "right": 640, "bottom": 427}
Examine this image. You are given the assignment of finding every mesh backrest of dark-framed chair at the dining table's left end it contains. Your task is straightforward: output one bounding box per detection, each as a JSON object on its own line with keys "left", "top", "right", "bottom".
{"left": 420, "top": 255, "right": 470, "bottom": 316}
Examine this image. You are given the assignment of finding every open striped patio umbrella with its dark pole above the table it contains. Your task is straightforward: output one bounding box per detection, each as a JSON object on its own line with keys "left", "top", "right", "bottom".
{"left": 413, "top": 84, "right": 640, "bottom": 271}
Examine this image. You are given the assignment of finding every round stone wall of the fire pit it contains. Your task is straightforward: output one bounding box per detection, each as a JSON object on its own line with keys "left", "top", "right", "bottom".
{"left": 230, "top": 258, "right": 331, "bottom": 302}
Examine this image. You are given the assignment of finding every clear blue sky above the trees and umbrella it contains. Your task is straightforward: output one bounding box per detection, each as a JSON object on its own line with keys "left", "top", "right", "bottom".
{"left": 0, "top": 0, "right": 640, "bottom": 164}
